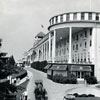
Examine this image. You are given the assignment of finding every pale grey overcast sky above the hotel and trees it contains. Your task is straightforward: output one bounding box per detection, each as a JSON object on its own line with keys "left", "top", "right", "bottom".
{"left": 0, "top": 0, "right": 100, "bottom": 61}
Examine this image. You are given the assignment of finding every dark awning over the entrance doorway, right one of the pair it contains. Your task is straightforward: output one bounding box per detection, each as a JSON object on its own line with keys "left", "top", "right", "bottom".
{"left": 70, "top": 65, "right": 92, "bottom": 72}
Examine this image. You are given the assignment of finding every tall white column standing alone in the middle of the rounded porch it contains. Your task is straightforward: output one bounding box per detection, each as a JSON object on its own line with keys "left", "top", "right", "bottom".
{"left": 68, "top": 27, "right": 72, "bottom": 63}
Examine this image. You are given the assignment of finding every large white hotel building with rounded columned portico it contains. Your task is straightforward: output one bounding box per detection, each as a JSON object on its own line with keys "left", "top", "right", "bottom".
{"left": 32, "top": 12, "right": 100, "bottom": 80}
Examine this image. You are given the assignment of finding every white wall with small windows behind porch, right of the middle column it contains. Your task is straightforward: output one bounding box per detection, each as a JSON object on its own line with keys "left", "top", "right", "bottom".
{"left": 72, "top": 29, "right": 92, "bottom": 62}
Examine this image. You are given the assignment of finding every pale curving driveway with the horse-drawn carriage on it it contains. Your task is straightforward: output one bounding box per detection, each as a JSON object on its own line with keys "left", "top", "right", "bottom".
{"left": 26, "top": 68, "right": 100, "bottom": 100}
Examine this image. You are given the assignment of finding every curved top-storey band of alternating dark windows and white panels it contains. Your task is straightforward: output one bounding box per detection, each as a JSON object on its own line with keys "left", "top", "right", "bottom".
{"left": 50, "top": 12, "right": 100, "bottom": 26}
